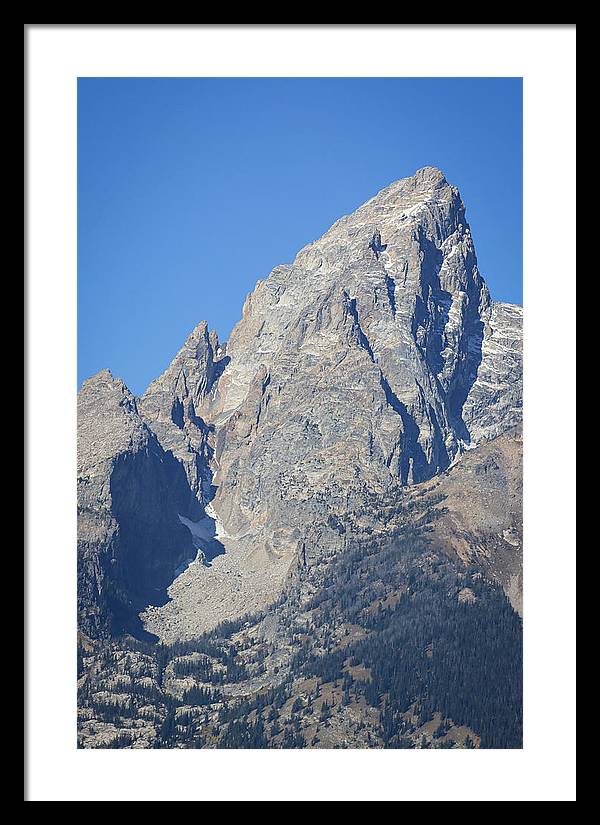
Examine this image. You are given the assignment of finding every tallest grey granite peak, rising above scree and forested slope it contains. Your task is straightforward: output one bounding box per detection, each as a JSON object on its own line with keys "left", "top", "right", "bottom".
{"left": 210, "top": 168, "right": 490, "bottom": 502}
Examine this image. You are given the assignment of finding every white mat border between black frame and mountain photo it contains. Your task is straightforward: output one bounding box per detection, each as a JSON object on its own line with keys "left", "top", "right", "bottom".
{"left": 27, "top": 26, "right": 575, "bottom": 801}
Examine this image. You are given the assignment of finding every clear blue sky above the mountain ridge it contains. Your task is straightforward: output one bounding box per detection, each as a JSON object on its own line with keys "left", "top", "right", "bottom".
{"left": 78, "top": 78, "right": 522, "bottom": 393}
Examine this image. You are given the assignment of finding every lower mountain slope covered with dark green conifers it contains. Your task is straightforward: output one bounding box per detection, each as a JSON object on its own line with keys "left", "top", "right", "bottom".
{"left": 79, "top": 428, "right": 521, "bottom": 748}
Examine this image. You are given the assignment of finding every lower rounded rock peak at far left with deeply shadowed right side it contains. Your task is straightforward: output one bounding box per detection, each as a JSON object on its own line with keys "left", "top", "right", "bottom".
{"left": 77, "top": 370, "right": 200, "bottom": 637}
